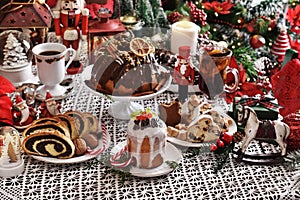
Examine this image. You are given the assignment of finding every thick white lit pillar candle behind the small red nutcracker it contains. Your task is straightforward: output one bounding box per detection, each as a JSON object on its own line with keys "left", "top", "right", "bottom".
{"left": 171, "top": 21, "right": 200, "bottom": 55}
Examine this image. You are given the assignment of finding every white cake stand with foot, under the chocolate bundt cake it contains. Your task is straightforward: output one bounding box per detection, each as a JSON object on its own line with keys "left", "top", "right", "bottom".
{"left": 81, "top": 65, "right": 172, "bottom": 120}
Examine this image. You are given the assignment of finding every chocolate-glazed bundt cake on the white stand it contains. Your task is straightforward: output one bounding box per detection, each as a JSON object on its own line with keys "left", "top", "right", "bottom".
{"left": 86, "top": 38, "right": 176, "bottom": 96}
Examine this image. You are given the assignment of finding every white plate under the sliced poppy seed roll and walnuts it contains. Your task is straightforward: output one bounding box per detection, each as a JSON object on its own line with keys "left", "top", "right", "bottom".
{"left": 31, "top": 133, "right": 110, "bottom": 164}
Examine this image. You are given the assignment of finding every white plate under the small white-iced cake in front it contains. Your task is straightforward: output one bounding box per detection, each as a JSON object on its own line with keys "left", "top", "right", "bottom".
{"left": 111, "top": 141, "right": 182, "bottom": 177}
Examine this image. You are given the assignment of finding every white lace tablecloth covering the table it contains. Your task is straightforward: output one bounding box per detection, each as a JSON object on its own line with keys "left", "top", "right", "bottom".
{"left": 0, "top": 75, "right": 300, "bottom": 200}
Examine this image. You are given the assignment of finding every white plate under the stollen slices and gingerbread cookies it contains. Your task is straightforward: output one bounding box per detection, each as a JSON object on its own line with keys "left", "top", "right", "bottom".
{"left": 167, "top": 114, "right": 237, "bottom": 147}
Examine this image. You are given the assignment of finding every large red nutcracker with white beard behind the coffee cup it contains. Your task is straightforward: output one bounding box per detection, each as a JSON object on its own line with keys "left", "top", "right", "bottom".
{"left": 53, "top": 0, "right": 89, "bottom": 74}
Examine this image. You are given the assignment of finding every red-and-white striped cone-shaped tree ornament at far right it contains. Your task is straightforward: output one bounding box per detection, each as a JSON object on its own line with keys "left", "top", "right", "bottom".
{"left": 271, "top": 28, "right": 291, "bottom": 62}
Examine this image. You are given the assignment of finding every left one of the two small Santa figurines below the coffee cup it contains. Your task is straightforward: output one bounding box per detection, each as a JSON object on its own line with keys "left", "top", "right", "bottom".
{"left": 11, "top": 94, "right": 37, "bottom": 126}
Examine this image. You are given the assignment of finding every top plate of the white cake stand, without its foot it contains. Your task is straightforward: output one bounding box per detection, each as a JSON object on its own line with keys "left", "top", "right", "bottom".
{"left": 81, "top": 65, "right": 172, "bottom": 101}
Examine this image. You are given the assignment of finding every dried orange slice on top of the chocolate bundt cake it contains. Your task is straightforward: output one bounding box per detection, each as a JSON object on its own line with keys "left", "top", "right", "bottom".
{"left": 129, "top": 38, "right": 152, "bottom": 56}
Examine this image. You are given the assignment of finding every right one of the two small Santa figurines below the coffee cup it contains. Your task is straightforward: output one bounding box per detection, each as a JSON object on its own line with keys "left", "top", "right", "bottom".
{"left": 39, "top": 91, "right": 61, "bottom": 117}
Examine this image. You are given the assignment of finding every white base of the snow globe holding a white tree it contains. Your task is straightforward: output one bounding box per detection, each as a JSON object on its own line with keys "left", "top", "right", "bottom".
{"left": 0, "top": 62, "right": 33, "bottom": 86}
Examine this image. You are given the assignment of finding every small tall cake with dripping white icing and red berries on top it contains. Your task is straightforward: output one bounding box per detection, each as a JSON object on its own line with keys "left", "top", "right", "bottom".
{"left": 127, "top": 109, "right": 167, "bottom": 169}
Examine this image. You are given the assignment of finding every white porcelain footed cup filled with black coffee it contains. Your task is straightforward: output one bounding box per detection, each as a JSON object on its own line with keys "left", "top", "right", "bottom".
{"left": 32, "top": 43, "right": 76, "bottom": 97}
